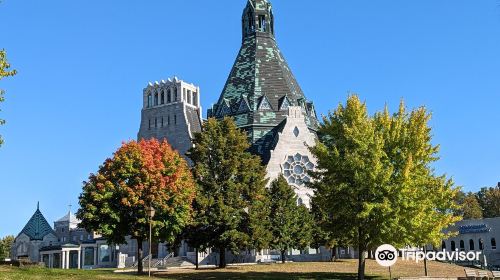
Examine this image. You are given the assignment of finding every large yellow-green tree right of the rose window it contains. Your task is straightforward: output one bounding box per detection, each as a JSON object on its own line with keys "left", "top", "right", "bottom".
{"left": 310, "top": 95, "right": 459, "bottom": 279}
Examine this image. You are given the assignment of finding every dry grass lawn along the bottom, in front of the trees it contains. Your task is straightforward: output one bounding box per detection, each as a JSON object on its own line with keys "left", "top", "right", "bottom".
{"left": 0, "top": 260, "right": 478, "bottom": 280}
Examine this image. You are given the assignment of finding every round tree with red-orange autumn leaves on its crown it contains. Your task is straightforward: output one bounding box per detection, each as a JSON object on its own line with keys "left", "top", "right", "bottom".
{"left": 77, "top": 139, "right": 195, "bottom": 273}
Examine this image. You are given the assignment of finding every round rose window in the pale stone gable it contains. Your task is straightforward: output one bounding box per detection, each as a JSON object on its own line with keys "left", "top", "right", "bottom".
{"left": 281, "top": 154, "right": 314, "bottom": 186}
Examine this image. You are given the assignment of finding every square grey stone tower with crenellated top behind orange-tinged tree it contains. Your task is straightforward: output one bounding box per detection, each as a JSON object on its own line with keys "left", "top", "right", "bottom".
{"left": 137, "top": 77, "right": 202, "bottom": 160}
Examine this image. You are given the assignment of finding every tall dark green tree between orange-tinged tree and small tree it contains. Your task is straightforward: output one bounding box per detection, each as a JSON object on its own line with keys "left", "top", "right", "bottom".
{"left": 189, "top": 118, "right": 269, "bottom": 268}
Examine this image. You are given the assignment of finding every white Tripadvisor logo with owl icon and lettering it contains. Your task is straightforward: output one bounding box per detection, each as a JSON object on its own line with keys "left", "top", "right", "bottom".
{"left": 375, "top": 244, "right": 481, "bottom": 267}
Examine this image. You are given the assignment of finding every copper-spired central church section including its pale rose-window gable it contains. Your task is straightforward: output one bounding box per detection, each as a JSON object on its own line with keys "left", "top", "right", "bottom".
{"left": 208, "top": 0, "right": 318, "bottom": 205}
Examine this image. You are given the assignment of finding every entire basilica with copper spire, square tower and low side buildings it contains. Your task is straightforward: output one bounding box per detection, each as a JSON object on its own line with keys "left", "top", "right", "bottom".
{"left": 13, "top": 0, "right": 348, "bottom": 268}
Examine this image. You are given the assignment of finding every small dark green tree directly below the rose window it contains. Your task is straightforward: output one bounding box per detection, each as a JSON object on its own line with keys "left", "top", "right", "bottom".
{"left": 268, "top": 176, "right": 312, "bottom": 263}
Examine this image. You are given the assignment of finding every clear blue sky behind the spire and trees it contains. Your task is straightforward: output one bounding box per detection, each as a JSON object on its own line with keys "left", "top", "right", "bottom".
{"left": 0, "top": 0, "right": 500, "bottom": 236}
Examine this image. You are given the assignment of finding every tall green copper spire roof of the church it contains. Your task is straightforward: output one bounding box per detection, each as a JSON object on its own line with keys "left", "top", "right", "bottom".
{"left": 208, "top": 0, "right": 318, "bottom": 162}
